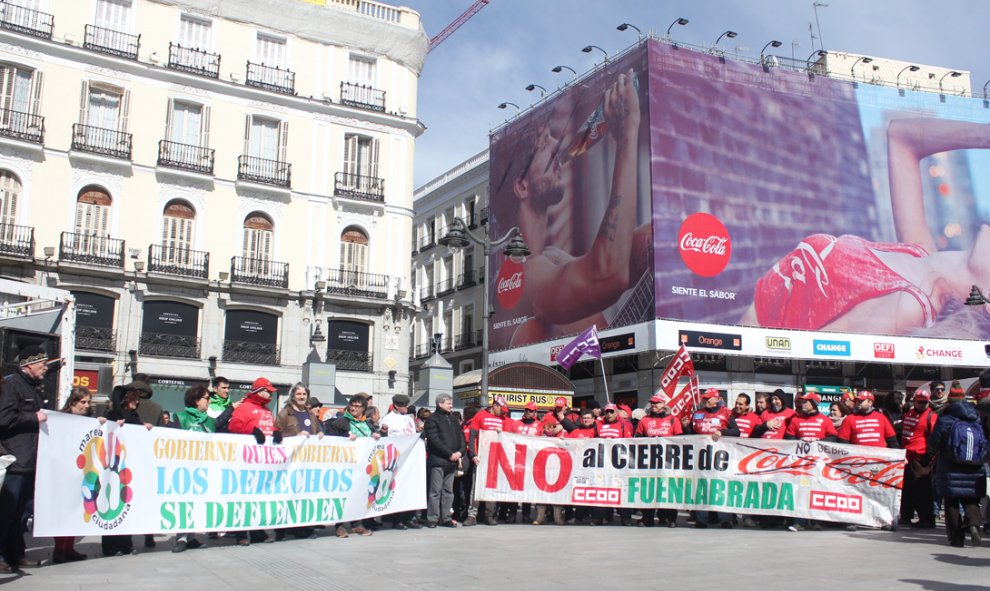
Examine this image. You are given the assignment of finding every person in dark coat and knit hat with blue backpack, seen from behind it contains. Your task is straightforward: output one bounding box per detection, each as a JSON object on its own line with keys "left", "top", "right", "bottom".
{"left": 917, "top": 382, "right": 987, "bottom": 548}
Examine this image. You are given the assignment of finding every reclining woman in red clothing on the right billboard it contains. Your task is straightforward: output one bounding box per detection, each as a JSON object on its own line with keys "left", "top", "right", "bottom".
{"left": 741, "top": 117, "right": 990, "bottom": 338}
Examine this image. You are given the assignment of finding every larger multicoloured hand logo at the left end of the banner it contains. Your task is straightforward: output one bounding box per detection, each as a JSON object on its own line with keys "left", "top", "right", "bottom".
{"left": 76, "top": 430, "right": 134, "bottom": 530}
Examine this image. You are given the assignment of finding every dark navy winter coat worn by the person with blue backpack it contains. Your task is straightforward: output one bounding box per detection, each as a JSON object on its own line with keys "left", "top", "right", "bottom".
{"left": 922, "top": 401, "right": 986, "bottom": 497}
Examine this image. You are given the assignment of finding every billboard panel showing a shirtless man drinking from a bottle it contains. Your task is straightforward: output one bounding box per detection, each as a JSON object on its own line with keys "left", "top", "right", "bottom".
{"left": 487, "top": 48, "right": 653, "bottom": 349}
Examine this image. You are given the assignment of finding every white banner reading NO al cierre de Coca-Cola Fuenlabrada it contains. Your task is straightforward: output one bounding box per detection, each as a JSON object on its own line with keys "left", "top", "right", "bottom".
{"left": 474, "top": 431, "right": 905, "bottom": 526}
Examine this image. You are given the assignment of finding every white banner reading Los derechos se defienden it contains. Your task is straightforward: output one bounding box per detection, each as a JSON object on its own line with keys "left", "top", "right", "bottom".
{"left": 34, "top": 413, "right": 426, "bottom": 537}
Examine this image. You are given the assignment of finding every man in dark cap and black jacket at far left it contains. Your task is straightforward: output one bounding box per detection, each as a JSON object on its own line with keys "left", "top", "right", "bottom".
{"left": 0, "top": 345, "right": 48, "bottom": 574}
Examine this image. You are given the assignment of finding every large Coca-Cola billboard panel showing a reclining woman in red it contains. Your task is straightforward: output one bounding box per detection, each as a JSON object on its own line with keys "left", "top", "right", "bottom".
{"left": 650, "top": 43, "right": 990, "bottom": 339}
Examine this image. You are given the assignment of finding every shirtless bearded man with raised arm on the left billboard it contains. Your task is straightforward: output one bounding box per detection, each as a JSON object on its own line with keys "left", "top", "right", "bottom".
{"left": 491, "top": 70, "right": 651, "bottom": 345}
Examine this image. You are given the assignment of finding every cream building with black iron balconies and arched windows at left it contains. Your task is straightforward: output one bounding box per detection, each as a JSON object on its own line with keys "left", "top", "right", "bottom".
{"left": 0, "top": 0, "right": 428, "bottom": 410}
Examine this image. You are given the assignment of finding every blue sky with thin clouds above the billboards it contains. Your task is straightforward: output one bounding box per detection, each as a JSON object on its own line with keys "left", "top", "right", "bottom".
{"left": 402, "top": 0, "right": 990, "bottom": 187}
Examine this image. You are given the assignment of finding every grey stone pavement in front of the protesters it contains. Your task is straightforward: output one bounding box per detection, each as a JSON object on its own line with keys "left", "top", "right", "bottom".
{"left": 0, "top": 524, "right": 990, "bottom": 591}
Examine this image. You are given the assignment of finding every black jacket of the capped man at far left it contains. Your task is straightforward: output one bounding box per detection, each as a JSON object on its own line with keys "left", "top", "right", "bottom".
{"left": 0, "top": 370, "right": 45, "bottom": 474}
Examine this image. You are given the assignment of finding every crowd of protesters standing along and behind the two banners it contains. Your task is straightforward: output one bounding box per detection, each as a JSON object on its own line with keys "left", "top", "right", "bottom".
{"left": 0, "top": 347, "right": 990, "bottom": 573}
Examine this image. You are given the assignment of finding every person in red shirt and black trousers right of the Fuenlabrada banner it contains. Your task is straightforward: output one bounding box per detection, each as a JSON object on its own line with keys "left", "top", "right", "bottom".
{"left": 901, "top": 390, "right": 937, "bottom": 529}
